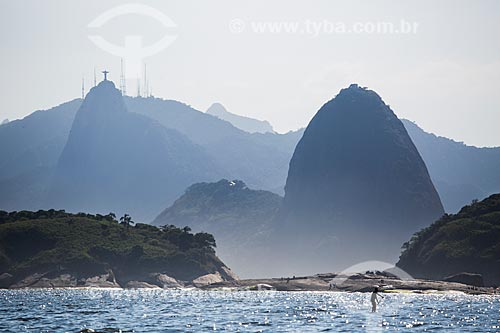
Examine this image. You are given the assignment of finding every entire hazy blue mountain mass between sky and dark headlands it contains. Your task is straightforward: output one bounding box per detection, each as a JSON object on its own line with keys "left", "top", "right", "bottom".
{"left": 0, "top": 81, "right": 500, "bottom": 276}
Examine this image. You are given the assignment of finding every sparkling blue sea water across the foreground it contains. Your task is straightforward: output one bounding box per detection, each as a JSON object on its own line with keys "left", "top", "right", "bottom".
{"left": 0, "top": 289, "right": 500, "bottom": 332}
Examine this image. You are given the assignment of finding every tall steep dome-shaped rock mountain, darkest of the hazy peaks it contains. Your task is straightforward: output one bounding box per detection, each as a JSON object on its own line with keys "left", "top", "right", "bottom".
{"left": 278, "top": 84, "right": 444, "bottom": 274}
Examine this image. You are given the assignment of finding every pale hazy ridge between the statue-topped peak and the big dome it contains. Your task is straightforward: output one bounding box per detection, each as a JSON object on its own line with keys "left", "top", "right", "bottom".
{"left": 125, "top": 97, "right": 302, "bottom": 197}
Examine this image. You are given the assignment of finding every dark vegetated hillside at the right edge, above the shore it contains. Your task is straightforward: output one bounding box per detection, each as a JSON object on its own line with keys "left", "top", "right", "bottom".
{"left": 397, "top": 194, "right": 500, "bottom": 285}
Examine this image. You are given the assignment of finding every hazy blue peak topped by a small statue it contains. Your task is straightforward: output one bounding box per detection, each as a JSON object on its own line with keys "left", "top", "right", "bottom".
{"left": 47, "top": 81, "right": 223, "bottom": 218}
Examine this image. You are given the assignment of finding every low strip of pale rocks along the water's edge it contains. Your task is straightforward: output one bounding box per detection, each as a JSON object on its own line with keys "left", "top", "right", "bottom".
{"left": 0, "top": 271, "right": 499, "bottom": 295}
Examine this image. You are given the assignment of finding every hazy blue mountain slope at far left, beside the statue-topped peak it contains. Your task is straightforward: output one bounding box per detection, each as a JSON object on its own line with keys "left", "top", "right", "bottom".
{"left": 0, "top": 99, "right": 82, "bottom": 210}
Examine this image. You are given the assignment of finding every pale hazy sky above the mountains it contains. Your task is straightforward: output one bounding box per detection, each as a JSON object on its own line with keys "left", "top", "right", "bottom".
{"left": 0, "top": 0, "right": 500, "bottom": 146}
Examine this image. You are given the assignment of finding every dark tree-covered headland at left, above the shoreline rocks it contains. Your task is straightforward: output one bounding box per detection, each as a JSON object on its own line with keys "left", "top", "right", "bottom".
{"left": 0, "top": 210, "right": 223, "bottom": 280}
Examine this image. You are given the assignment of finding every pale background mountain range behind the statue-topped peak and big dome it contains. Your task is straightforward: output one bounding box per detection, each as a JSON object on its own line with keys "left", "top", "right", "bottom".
{"left": 0, "top": 82, "right": 500, "bottom": 221}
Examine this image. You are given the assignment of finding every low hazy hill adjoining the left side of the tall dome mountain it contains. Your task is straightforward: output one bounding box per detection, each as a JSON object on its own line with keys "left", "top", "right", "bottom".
{"left": 153, "top": 179, "right": 283, "bottom": 276}
